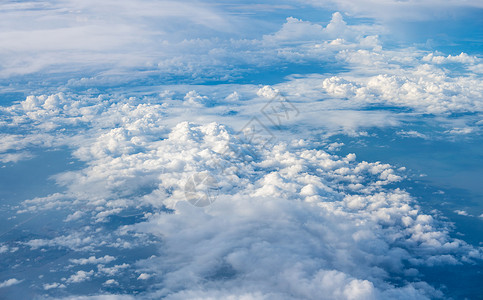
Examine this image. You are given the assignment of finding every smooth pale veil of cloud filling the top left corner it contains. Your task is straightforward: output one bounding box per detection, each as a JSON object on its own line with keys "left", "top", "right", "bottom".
{"left": 0, "top": 0, "right": 233, "bottom": 78}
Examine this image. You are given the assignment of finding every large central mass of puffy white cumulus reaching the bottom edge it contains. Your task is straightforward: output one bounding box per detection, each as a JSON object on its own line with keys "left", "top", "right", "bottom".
{"left": 5, "top": 94, "right": 480, "bottom": 299}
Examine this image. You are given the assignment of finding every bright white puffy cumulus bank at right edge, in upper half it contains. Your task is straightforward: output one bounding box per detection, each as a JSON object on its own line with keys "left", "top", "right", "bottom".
{"left": 279, "top": 61, "right": 483, "bottom": 114}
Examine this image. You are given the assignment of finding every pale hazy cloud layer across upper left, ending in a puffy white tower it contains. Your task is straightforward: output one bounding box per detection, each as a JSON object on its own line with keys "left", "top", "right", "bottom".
{"left": 0, "top": 4, "right": 390, "bottom": 86}
